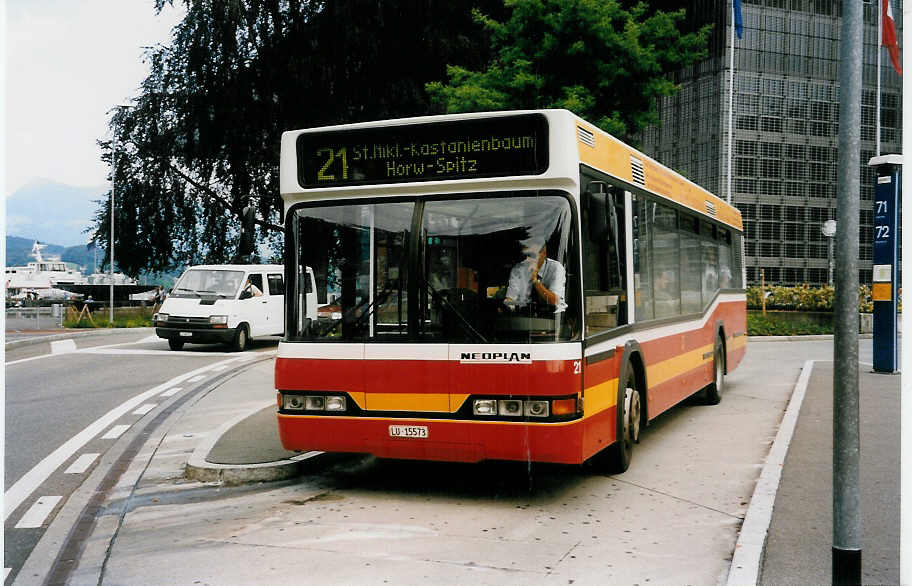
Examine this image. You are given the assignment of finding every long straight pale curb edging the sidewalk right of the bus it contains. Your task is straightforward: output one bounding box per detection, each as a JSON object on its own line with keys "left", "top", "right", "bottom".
{"left": 726, "top": 360, "right": 816, "bottom": 586}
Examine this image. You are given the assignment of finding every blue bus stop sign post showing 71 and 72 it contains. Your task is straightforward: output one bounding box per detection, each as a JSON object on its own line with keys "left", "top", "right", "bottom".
{"left": 868, "top": 155, "right": 902, "bottom": 374}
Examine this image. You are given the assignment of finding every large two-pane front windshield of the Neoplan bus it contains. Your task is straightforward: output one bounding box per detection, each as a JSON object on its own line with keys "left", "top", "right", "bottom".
{"left": 290, "top": 191, "right": 580, "bottom": 343}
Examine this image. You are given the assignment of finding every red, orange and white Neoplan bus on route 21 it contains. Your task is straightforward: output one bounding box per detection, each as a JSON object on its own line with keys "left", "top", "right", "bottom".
{"left": 275, "top": 110, "right": 747, "bottom": 472}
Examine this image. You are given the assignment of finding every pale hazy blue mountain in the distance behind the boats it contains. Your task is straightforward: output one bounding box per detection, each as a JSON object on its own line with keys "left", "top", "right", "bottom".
{"left": 6, "top": 180, "right": 108, "bottom": 248}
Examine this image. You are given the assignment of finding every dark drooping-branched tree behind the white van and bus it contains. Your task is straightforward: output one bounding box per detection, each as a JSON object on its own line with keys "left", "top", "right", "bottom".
{"left": 95, "top": 0, "right": 503, "bottom": 276}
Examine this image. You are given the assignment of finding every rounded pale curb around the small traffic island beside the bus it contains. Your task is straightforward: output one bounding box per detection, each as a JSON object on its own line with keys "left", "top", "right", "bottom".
{"left": 184, "top": 401, "right": 325, "bottom": 486}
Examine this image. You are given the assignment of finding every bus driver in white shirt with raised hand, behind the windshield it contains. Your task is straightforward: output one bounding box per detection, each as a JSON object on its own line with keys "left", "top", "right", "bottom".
{"left": 504, "top": 244, "right": 567, "bottom": 313}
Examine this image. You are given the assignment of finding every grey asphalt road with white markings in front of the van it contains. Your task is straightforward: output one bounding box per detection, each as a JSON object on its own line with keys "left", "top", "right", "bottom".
{"left": 4, "top": 329, "right": 275, "bottom": 579}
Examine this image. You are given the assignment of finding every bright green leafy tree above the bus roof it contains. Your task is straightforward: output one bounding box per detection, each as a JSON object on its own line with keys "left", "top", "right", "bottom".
{"left": 426, "top": 0, "right": 711, "bottom": 140}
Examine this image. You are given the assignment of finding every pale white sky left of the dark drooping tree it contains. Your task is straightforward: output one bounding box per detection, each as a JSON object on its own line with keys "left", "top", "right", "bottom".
{"left": 3, "top": 0, "right": 184, "bottom": 197}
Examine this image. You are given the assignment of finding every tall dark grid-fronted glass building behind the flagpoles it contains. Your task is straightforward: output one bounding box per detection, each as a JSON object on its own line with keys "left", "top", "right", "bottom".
{"left": 642, "top": 0, "right": 903, "bottom": 285}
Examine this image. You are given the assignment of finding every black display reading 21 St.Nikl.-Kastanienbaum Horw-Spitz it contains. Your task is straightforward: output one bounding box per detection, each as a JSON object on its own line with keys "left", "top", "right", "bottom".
{"left": 297, "top": 114, "right": 548, "bottom": 189}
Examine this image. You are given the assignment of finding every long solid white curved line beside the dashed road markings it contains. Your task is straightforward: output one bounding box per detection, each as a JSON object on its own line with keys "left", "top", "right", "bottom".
{"left": 3, "top": 358, "right": 246, "bottom": 520}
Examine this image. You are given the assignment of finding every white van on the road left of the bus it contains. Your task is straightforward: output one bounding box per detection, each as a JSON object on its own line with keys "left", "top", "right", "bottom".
{"left": 153, "top": 265, "right": 316, "bottom": 352}
